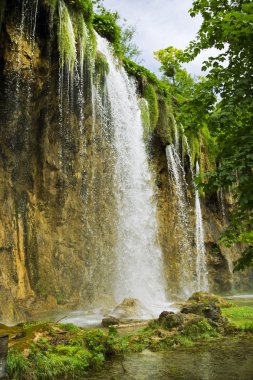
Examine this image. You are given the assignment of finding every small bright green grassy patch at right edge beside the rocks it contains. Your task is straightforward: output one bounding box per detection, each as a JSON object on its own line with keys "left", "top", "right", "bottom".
{"left": 222, "top": 306, "right": 253, "bottom": 332}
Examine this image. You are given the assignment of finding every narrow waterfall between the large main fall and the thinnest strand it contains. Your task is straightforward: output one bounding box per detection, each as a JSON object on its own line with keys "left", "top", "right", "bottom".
{"left": 166, "top": 144, "right": 194, "bottom": 297}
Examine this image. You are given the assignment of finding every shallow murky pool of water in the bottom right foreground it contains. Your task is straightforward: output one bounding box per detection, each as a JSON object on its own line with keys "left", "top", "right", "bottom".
{"left": 85, "top": 336, "right": 253, "bottom": 380}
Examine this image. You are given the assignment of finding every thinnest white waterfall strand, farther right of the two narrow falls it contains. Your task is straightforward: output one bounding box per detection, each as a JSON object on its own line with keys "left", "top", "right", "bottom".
{"left": 195, "top": 161, "right": 208, "bottom": 291}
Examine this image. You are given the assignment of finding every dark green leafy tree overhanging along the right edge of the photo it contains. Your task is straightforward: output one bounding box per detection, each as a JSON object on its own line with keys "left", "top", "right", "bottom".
{"left": 182, "top": 0, "right": 253, "bottom": 270}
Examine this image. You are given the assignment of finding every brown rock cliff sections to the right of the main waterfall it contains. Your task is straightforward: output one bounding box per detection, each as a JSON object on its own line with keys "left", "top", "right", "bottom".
{"left": 152, "top": 137, "right": 253, "bottom": 296}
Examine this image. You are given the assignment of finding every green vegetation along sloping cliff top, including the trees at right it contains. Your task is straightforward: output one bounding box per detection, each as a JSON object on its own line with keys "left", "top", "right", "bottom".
{"left": 56, "top": 0, "right": 253, "bottom": 269}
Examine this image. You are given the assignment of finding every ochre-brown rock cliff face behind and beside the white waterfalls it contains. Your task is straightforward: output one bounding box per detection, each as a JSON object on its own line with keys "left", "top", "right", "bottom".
{"left": 0, "top": 1, "right": 249, "bottom": 323}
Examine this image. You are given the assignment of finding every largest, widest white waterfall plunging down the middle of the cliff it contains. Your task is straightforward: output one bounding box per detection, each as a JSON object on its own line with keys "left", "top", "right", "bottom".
{"left": 97, "top": 36, "right": 166, "bottom": 310}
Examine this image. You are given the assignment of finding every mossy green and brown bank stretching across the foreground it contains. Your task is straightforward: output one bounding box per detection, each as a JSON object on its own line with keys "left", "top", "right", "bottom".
{"left": 0, "top": 300, "right": 253, "bottom": 380}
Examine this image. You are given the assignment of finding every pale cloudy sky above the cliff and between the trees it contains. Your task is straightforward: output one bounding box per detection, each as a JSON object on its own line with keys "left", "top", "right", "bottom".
{"left": 104, "top": 0, "right": 206, "bottom": 75}
